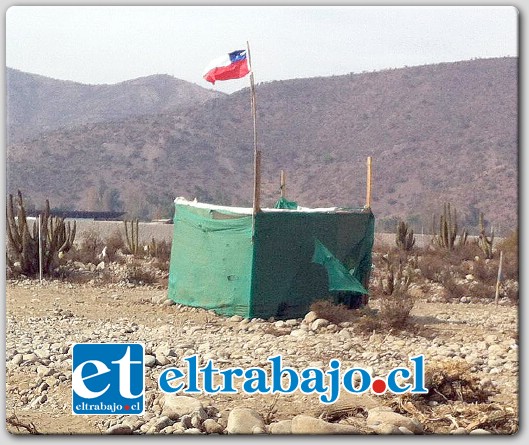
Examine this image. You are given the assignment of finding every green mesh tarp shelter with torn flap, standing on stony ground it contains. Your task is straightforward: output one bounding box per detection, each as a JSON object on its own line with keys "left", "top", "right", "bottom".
{"left": 168, "top": 198, "right": 375, "bottom": 319}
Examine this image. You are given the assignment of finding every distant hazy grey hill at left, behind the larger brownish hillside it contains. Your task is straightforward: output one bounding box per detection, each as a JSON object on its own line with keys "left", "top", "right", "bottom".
{"left": 6, "top": 68, "right": 223, "bottom": 142}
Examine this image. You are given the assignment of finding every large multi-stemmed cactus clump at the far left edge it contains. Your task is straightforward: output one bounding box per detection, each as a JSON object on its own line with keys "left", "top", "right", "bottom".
{"left": 6, "top": 190, "right": 76, "bottom": 276}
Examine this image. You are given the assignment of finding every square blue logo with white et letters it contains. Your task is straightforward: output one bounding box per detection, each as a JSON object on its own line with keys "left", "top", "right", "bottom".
{"left": 72, "top": 343, "right": 145, "bottom": 415}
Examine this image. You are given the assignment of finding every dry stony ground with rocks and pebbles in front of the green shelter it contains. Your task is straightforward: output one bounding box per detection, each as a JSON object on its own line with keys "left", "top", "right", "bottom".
{"left": 6, "top": 279, "right": 519, "bottom": 434}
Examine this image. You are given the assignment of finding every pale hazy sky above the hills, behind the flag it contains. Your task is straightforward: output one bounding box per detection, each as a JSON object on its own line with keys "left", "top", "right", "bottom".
{"left": 6, "top": 6, "right": 518, "bottom": 92}
